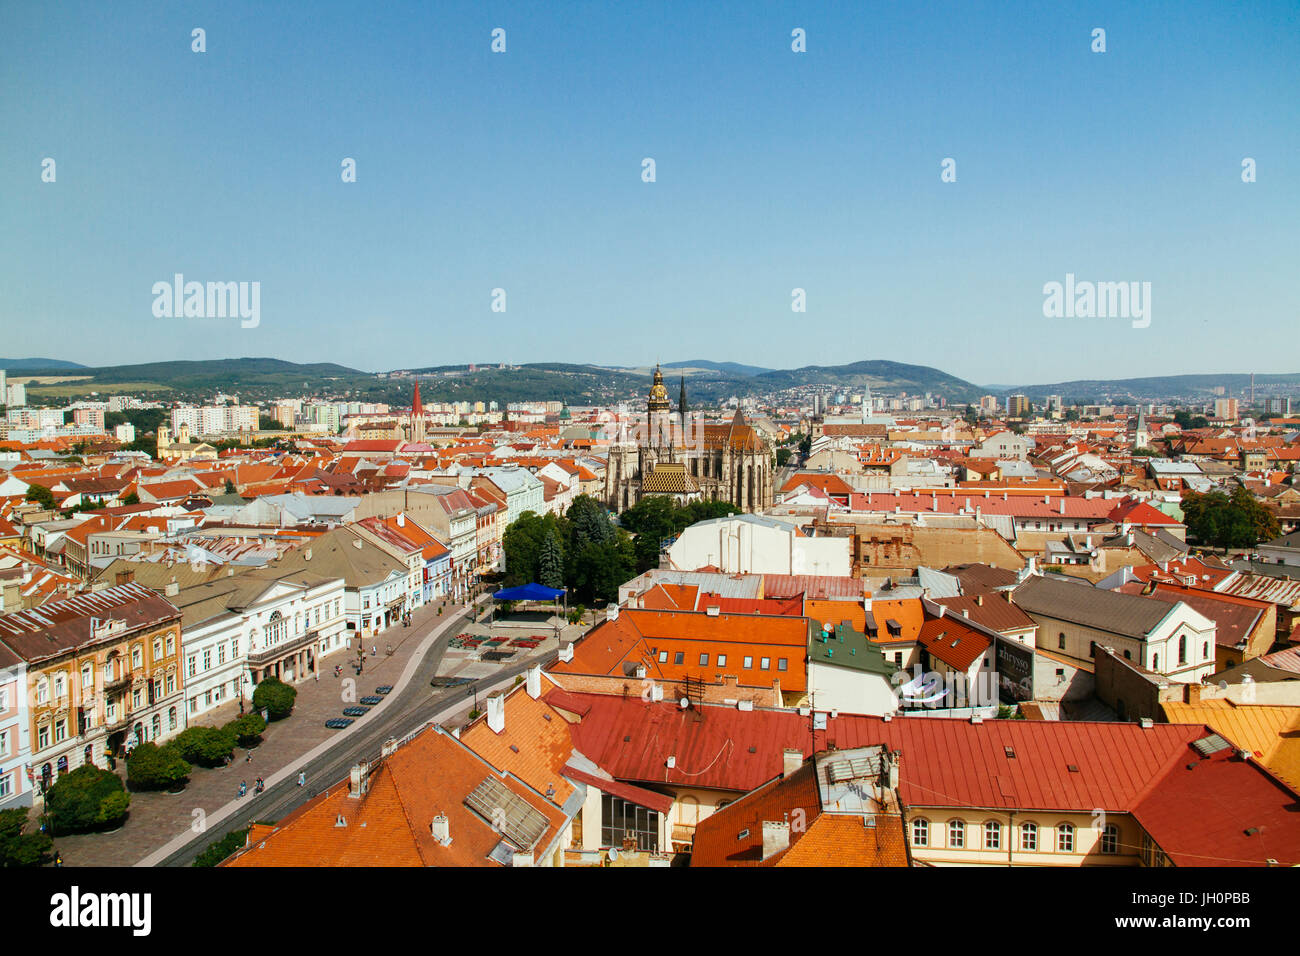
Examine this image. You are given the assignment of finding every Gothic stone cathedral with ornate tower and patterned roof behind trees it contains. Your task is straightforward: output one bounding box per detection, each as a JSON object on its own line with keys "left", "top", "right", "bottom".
{"left": 605, "top": 365, "right": 774, "bottom": 511}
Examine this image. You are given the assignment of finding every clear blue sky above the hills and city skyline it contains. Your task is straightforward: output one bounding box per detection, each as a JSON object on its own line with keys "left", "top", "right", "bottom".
{"left": 0, "top": 0, "right": 1300, "bottom": 382}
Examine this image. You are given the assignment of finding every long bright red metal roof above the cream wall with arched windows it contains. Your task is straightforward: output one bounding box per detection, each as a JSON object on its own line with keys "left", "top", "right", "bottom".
{"left": 547, "top": 692, "right": 1208, "bottom": 813}
